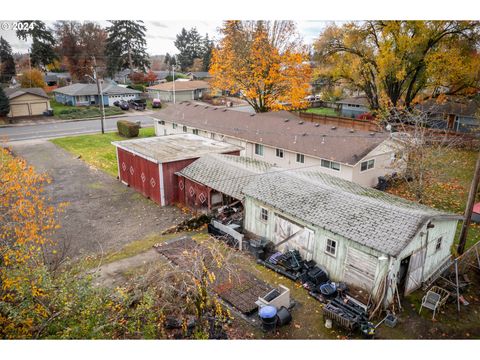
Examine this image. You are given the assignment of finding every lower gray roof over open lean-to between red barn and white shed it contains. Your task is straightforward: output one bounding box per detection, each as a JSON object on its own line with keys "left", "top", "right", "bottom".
{"left": 178, "top": 154, "right": 273, "bottom": 200}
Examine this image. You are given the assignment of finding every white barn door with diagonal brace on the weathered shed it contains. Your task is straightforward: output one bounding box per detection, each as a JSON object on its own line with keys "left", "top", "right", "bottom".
{"left": 272, "top": 216, "right": 314, "bottom": 260}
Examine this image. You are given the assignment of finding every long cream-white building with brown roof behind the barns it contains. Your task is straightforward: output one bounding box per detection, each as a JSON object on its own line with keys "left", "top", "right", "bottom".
{"left": 155, "top": 102, "right": 398, "bottom": 186}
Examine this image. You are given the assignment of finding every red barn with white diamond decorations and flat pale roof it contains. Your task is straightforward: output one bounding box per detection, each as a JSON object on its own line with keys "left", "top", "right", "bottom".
{"left": 112, "top": 134, "right": 242, "bottom": 206}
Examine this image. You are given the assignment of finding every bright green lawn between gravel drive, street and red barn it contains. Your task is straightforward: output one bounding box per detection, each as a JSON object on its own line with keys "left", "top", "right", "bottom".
{"left": 51, "top": 128, "right": 155, "bottom": 177}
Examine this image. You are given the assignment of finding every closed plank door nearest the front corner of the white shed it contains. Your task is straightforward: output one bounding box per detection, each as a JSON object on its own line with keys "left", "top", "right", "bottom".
{"left": 344, "top": 247, "right": 378, "bottom": 291}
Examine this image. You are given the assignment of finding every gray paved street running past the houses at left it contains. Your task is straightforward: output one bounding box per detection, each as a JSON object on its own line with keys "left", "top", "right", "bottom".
{"left": 0, "top": 115, "right": 153, "bottom": 141}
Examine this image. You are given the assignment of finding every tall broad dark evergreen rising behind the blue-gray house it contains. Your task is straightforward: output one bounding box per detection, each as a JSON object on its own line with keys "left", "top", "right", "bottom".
{"left": 105, "top": 20, "right": 150, "bottom": 76}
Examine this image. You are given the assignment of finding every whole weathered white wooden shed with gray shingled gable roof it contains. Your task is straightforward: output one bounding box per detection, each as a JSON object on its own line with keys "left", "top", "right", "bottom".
{"left": 243, "top": 169, "right": 461, "bottom": 305}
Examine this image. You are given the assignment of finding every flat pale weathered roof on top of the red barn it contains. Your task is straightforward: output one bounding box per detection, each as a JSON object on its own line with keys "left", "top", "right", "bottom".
{"left": 112, "top": 134, "right": 242, "bottom": 163}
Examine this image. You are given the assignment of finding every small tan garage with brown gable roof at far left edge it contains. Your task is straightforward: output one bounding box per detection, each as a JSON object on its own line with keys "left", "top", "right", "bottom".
{"left": 5, "top": 88, "right": 50, "bottom": 117}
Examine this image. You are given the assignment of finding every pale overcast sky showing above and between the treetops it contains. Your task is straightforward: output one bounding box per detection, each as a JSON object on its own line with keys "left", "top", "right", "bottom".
{"left": 0, "top": 21, "right": 327, "bottom": 55}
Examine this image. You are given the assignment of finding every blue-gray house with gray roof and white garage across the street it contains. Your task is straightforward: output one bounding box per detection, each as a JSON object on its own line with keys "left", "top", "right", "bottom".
{"left": 53, "top": 81, "right": 141, "bottom": 106}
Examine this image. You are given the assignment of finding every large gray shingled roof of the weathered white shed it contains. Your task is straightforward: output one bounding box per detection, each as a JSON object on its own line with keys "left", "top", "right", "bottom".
{"left": 243, "top": 170, "right": 461, "bottom": 256}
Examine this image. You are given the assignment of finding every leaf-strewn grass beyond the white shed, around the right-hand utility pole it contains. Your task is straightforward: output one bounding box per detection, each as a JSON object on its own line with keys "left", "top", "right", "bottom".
{"left": 388, "top": 149, "right": 480, "bottom": 252}
